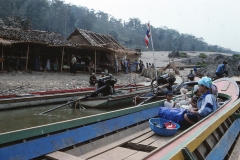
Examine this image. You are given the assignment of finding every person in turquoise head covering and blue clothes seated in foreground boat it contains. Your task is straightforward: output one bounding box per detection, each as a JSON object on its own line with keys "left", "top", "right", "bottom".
{"left": 184, "top": 77, "right": 217, "bottom": 124}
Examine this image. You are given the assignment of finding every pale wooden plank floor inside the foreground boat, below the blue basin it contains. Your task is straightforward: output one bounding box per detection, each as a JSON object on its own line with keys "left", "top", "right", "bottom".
{"left": 46, "top": 121, "right": 181, "bottom": 160}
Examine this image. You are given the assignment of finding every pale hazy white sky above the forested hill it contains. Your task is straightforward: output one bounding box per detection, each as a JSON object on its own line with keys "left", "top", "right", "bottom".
{"left": 65, "top": 0, "right": 240, "bottom": 51}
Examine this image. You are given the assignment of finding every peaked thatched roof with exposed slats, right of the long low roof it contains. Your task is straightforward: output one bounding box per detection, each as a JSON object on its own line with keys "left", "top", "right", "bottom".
{"left": 68, "top": 28, "right": 128, "bottom": 50}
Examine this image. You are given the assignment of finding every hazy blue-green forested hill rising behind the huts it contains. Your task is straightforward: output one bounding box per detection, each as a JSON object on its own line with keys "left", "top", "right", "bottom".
{"left": 0, "top": 0, "right": 237, "bottom": 53}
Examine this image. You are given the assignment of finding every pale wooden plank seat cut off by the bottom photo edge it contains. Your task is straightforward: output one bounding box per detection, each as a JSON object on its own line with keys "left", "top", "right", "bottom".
{"left": 46, "top": 151, "right": 83, "bottom": 160}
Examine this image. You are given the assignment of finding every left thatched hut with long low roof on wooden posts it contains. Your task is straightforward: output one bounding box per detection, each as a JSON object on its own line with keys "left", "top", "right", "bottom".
{"left": 0, "top": 28, "right": 76, "bottom": 70}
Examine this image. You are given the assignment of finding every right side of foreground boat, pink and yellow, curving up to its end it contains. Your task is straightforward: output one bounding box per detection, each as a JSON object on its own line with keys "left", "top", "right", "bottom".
{"left": 144, "top": 78, "right": 240, "bottom": 160}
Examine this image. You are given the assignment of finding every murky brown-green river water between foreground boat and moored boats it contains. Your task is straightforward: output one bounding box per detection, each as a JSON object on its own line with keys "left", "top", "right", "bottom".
{"left": 0, "top": 104, "right": 129, "bottom": 133}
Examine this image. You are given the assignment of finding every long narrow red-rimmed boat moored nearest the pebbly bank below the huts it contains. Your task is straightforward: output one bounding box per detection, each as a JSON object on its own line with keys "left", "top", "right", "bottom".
{"left": 0, "top": 83, "right": 150, "bottom": 110}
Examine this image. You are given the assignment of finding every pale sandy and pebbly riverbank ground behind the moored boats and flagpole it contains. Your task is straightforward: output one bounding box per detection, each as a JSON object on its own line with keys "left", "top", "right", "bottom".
{"left": 0, "top": 51, "right": 231, "bottom": 95}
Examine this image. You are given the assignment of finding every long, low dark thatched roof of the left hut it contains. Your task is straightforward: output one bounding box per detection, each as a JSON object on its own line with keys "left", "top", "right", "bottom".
{"left": 0, "top": 28, "right": 72, "bottom": 46}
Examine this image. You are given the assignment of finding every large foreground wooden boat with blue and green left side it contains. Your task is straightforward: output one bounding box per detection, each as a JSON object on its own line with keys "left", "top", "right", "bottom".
{"left": 0, "top": 79, "right": 240, "bottom": 159}
